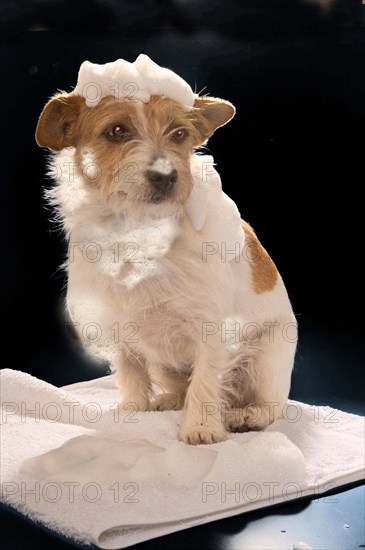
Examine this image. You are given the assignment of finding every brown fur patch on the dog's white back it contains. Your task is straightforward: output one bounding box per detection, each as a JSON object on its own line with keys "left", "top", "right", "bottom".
{"left": 241, "top": 220, "right": 279, "bottom": 294}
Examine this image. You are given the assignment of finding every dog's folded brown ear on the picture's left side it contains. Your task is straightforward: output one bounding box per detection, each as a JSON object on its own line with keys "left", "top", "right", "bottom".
{"left": 35, "top": 94, "right": 84, "bottom": 151}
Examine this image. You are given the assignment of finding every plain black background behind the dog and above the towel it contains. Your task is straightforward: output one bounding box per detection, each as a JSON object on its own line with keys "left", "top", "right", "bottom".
{"left": 0, "top": 0, "right": 365, "bottom": 550}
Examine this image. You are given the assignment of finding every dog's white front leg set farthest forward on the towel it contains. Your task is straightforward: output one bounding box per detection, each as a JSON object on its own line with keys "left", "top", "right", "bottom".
{"left": 178, "top": 342, "right": 227, "bottom": 445}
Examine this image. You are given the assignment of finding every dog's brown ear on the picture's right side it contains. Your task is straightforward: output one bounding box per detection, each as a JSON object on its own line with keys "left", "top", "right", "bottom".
{"left": 192, "top": 97, "right": 236, "bottom": 146}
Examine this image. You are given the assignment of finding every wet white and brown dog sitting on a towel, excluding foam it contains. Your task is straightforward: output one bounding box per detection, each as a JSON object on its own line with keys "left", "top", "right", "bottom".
{"left": 36, "top": 61, "right": 297, "bottom": 445}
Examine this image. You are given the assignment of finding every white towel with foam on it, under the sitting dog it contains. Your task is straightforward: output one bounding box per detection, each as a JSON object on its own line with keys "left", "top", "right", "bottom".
{"left": 0, "top": 369, "right": 364, "bottom": 548}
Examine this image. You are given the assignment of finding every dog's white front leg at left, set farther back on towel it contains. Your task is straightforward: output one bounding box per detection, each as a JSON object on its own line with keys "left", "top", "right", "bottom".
{"left": 115, "top": 350, "right": 151, "bottom": 412}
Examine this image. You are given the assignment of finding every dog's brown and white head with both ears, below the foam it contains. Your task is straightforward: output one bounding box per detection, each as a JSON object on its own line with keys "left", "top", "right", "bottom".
{"left": 36, "top": 93, "right": 235, "bottom": 212}
